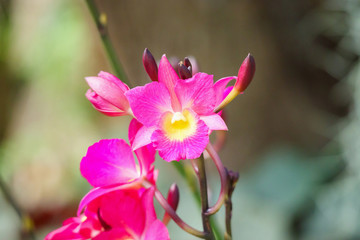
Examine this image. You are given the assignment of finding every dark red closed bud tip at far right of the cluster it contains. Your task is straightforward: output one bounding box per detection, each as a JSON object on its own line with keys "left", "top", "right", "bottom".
{"left": 234, "top": 53, "right": 255, "bottom": 93}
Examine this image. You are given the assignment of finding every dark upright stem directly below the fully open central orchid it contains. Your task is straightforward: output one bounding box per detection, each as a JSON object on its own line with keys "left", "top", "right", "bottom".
{"left": 197, "top": 154, "right": 215, "bottom": 240}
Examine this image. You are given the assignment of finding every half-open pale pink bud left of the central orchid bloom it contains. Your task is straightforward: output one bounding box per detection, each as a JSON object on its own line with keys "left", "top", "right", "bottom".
{"left": 85, "top": 71, "right": 132, "bottom": 117}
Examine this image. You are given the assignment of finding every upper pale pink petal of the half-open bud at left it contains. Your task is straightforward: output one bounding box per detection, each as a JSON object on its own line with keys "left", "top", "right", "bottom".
{"left": 85, "top": 77, "right": 129, "bottom": 111}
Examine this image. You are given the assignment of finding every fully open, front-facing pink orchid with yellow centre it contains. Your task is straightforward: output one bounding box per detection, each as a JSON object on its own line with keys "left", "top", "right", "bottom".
{"left": 125, "top": 55, "right": 227, "bottom": 161}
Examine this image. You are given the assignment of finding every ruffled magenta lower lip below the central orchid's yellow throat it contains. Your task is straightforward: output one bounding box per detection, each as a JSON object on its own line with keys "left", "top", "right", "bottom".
{"left": 151, "top": 113, "right": 209, "bottom": 162}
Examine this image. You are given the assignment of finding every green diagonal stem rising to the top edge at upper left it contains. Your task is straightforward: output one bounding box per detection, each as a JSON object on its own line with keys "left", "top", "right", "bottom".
{"left": 86, "top": 0, "right": 131, "bottom": 86}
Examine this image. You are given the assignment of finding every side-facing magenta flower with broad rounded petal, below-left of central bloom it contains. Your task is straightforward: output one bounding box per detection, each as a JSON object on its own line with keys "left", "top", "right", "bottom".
{"left": 78, "top": 135, "right": 157, "bottom": 214}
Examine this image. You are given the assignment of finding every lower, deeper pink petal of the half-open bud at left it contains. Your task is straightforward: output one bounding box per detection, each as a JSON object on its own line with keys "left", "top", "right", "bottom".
{"left": 85, "top": 89, "right": 128, "bottom": 117}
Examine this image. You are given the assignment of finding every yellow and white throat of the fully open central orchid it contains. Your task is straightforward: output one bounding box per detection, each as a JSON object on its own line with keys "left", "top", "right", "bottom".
{"left": 162, "top": 109, "right": 196, "bottom": 141}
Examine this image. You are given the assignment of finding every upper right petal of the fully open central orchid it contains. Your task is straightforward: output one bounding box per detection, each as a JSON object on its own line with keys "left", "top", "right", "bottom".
{"left": 175, "top": 73, "right": 216, "bottom": 115}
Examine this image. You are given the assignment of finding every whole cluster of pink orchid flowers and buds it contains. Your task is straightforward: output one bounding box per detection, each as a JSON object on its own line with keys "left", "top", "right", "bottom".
{"left": 45, "top": 49, "right": 255, "bottom": 240}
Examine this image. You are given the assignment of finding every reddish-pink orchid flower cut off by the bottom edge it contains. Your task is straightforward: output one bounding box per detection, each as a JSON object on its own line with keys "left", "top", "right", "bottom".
{"left": 45, "top": 188, "right": 170, "bottom": 240}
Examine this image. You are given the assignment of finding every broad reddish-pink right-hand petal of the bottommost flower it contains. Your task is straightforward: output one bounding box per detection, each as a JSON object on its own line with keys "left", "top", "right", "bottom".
{"left": 94, "top": 188, "right": 170, "bottom": 240}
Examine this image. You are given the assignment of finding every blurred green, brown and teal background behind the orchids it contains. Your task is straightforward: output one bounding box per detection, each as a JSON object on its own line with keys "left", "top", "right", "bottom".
{"left": 0, "top": 0, "right": 360, "bottom": 240}
